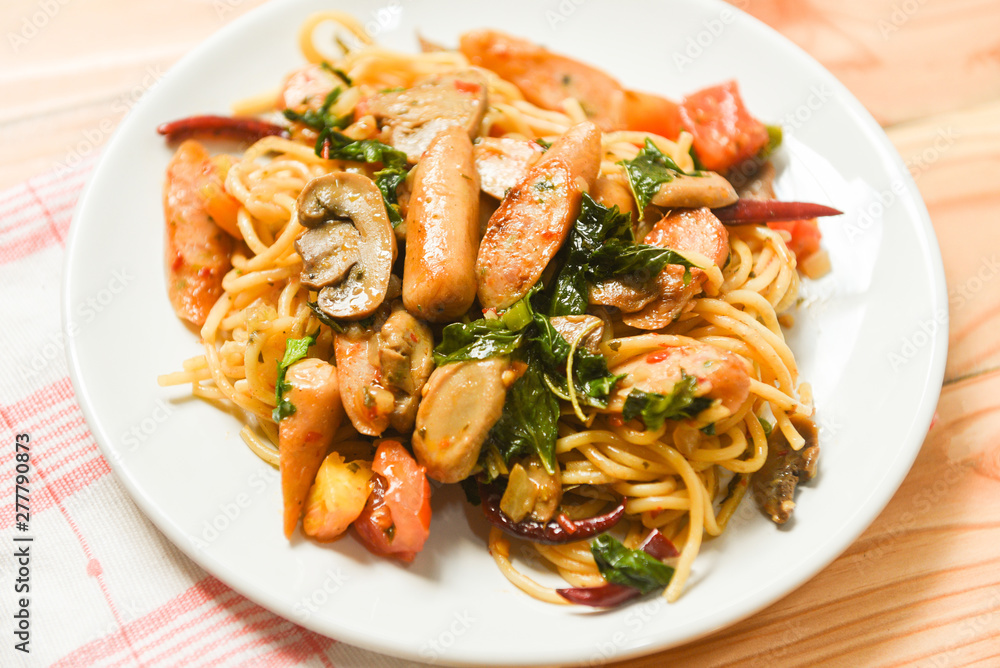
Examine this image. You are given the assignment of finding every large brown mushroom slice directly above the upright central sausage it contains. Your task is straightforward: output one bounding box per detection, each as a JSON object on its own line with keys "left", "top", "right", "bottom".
{"left": 359, "top": 70, "right": 487, "bottom": 163}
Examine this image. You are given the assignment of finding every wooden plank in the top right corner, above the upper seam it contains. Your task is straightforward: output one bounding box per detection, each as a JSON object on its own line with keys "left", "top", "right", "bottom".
{"left": 730, "top": 0, "right": 1000, "bottom": 125}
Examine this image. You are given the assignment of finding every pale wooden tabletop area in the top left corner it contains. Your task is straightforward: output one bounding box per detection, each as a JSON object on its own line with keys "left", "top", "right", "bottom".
{"left": 0, "top": 0, "right": 264, "bottom": 188}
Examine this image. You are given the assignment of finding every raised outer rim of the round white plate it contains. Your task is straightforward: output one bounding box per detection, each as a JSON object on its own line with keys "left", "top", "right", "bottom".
{"left": 60, "top": 0, "right": 948, "bottom": 666}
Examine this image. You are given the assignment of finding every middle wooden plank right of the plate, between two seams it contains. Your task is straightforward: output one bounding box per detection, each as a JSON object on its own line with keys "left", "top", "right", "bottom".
{"left": 889, "top": 102, "right": 1000, "bottom": 380}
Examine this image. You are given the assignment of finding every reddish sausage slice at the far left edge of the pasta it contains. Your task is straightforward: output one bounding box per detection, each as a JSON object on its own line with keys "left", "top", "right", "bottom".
{"left": 163, "top": 140, "right": 233, "bottom": 327}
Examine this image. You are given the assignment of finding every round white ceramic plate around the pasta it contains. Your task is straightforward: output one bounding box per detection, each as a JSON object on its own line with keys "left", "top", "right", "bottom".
{"left": 63, "top": 0, "right": 947, "bottom": 665}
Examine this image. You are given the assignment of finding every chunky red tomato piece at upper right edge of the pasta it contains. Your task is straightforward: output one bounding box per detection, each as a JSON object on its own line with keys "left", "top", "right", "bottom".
{"left": 680, "top": 81, "right": 768, "bottom": 172}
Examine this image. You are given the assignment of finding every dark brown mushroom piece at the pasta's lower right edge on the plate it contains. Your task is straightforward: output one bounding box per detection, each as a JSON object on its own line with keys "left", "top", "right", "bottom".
{"left": 753, "top": 415, "right": 819, "bottom": 524}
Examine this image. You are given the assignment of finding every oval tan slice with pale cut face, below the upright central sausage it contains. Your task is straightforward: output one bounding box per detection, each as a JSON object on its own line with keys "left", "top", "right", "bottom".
{"left": 413, "top": 357, "right": 509, "bottom": 482}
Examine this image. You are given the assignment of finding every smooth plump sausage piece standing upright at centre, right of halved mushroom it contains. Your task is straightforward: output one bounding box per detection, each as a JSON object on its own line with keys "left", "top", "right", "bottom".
{"left": 403, "top": 126, "right": 479, "bottom": 322}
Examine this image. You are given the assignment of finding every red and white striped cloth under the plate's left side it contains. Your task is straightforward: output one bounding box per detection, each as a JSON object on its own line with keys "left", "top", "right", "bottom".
{"left": 0, "top": 161, "right": 422, "bottom": 667}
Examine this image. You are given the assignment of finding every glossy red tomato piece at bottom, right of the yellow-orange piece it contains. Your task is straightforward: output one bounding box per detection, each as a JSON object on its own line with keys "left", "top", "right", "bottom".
{"left": 354, "top": 441, "right": 431, "bottom": 563}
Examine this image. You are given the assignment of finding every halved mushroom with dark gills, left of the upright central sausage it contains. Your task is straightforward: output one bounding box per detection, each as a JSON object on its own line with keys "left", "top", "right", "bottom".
{"left": 295, "top": 172, "right": 396, "bottom": 320}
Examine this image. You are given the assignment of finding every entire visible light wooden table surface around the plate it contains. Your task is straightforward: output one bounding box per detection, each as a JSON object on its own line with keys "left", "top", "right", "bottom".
{"left": 0, "top": 0, "right": 1000, "bottom": 668}
